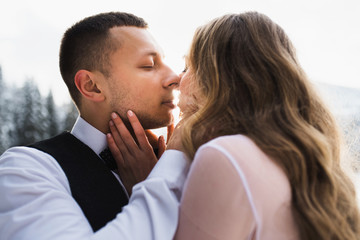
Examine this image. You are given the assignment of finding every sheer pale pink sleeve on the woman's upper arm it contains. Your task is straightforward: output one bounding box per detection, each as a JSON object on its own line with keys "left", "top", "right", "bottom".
{"left": 175, "top": 143, "right": 255, "bottom": 240}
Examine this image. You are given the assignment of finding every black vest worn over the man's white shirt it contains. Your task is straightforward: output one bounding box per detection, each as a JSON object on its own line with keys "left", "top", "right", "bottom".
{"left": 29, "top": 132, "right": 128, "bottom": 232}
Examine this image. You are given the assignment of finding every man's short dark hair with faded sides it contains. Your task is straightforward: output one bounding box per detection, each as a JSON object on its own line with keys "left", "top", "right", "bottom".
{"left": 59, "top": 12, "right": 147, "bottom": 106}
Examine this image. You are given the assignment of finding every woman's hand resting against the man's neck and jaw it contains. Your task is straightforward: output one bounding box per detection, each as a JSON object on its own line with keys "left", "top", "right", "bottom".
{"left": 107, "top": 111, "right": 159, "bottom": 195}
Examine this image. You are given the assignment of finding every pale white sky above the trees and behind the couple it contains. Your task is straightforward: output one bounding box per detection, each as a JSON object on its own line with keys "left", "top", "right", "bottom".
{"left": 0, "top": 0, "right": 360, "bottom": 103}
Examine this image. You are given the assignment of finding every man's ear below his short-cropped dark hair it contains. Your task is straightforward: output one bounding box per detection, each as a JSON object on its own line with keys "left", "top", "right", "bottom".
{"left": 74, "top": 70, "right": 105, "bottom": 102}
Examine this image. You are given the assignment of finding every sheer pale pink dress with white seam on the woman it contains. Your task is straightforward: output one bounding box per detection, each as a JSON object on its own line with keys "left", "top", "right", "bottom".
{"left": 175, "top": 135, "right": 299, "bottom": 240}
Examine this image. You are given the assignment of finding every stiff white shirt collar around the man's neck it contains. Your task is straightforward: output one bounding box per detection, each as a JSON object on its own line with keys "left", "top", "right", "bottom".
{"left": 71, "top": 116, "right": 107, "bottom": 155}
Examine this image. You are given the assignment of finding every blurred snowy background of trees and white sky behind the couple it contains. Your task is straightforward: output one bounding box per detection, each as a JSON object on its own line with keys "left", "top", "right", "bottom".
{"left": 0, "top": 0, "right": 360, "bottom": 199}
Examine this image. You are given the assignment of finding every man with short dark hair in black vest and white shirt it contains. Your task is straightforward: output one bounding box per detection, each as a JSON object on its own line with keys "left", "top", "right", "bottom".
{"left": 0, "top": 13, "right": 187, "bottom": 239}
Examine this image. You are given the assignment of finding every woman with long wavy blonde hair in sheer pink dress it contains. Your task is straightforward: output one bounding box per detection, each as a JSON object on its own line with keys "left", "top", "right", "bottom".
{"left": 107, "top": 12, "right": 360, "bottom": 239}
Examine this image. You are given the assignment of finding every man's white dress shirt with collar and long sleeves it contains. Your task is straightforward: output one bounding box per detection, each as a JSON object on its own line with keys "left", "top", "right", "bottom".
{"left": 0, "top": 118, "right": 189, "bottom": 240}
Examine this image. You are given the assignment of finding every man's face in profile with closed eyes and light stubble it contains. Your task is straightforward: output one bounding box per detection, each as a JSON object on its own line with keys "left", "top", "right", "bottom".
{"left": 106, "top": 27, "right": 179, "bottom": 129}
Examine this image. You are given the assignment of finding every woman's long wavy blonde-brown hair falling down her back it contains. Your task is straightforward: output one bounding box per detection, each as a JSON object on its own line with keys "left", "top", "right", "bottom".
{"left": 179, "top": 12, "right": 360, "bottom": 240}
